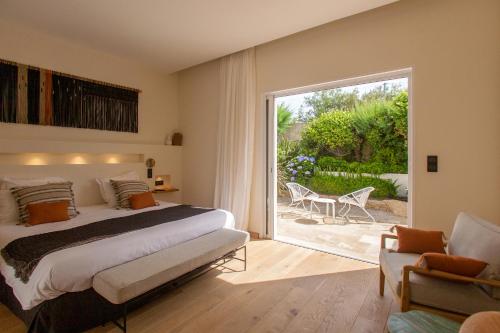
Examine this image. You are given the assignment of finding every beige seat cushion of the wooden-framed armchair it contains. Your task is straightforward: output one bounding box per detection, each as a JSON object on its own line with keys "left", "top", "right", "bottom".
{"left": 380, "top": 249, "right": 500, "bottom": 314}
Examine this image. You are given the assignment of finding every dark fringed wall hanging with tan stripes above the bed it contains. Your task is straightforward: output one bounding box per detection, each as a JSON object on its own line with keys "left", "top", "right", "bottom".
{"left": 0, "top": 59, "right": 139, "bottom": 133}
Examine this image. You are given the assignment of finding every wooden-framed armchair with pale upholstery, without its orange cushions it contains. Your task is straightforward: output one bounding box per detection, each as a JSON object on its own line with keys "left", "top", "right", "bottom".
{"left": 380, "top": 213, "right": 500, "bottom": 321}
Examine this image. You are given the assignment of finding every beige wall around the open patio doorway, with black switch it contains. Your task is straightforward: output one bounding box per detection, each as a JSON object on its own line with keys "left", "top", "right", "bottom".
{"left": 180, "top": 0, "right": 500, "bottom": 233}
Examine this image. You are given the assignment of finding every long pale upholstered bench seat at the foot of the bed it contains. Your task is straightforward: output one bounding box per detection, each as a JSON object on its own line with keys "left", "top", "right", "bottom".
{"left": 92, "top": 229, "right": 249, "bottom": 304}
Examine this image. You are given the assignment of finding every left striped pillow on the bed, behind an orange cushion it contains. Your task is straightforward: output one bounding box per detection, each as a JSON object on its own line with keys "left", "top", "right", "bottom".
{"left": 10, "top": 182, "right": 78, "bottom": 223}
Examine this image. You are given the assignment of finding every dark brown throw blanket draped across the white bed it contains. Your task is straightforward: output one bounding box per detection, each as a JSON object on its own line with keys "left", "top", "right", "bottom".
{"left": 1, "top": 205, "right": 213, "bottom": 283}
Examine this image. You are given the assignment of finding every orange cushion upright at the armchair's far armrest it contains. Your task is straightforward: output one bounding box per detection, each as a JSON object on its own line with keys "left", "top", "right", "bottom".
{"left": 396, "top": 225, "right": 446, "bottom": 253}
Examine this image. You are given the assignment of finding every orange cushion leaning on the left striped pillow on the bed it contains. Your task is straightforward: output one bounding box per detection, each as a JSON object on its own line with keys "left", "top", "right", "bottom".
{"left": 26, "top": 200, "right": 69, "bottom": 225}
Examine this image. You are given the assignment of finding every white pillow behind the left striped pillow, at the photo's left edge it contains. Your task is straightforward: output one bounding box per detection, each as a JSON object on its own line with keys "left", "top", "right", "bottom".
{"left": 0, "top": 177, "right": 66, "bottom": 224}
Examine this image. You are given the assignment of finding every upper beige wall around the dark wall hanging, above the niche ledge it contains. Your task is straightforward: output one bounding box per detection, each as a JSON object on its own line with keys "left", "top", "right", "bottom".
{"left": 0, "top": 20, "right": 178, "bottom": 143}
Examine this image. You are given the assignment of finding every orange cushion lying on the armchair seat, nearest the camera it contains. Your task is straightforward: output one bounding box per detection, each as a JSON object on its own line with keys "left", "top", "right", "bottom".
{"left": 416, "top": 253, "right": 488, "bottom": 277}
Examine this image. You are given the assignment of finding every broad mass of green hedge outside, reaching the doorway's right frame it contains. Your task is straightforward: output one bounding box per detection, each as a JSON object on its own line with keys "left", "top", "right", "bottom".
{"left": 301, "top": 92, "right": 408, "bottom": 174}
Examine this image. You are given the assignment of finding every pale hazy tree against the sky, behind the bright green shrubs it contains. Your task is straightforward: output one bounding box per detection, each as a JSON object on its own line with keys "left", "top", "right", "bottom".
{"left": 299, "top": 88, "right": 360, "bottom": 122}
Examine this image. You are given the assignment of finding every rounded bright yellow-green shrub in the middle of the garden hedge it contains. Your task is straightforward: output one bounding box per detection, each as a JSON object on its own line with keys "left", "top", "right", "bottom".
{"left": 302, "top": 111, "right": 358, "bottom": 156}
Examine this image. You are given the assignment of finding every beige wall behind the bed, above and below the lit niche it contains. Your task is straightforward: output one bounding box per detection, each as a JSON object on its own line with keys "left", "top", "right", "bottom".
{"left": 0, "top": 20, "right": 182, "bottom": 204}
